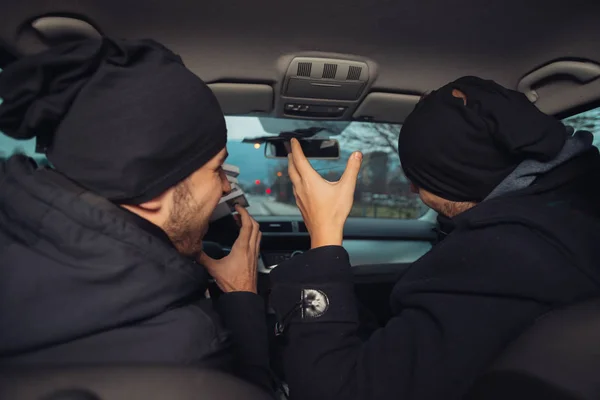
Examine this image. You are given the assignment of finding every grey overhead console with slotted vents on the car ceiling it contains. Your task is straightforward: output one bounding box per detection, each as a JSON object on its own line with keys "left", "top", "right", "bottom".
{"left": 276, "top": 57, "right": 374, "bottom": 119}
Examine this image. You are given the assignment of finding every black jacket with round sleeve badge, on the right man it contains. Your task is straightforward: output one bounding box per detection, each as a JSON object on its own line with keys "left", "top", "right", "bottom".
{"left": 271, "top": 149, "right": 600, "bottom": 400}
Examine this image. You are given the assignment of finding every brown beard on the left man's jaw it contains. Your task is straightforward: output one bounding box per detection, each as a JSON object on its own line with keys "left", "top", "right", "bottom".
{"left": 165, "top": 182, "right": 206, "bottom": 257}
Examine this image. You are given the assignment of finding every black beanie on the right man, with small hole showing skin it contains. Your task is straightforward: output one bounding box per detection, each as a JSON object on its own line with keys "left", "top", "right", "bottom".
{"left": 398, "top": 76, "right": 567, "bottom": 202}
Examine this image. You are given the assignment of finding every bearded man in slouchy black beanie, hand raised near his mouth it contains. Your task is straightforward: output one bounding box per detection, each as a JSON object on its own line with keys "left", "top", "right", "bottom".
{"left": 0, "top": 38, "right": 269, "bottom": 389}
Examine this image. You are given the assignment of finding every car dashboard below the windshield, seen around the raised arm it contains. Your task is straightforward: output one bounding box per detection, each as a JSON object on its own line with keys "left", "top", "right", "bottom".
{"left": 204, "top": 216, "right": 437, "bottom": 326}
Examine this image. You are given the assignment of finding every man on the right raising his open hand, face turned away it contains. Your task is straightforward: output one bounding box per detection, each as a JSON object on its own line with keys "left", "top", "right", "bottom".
{"left": 270, "top": 77, "right": 600, "bottom": 400}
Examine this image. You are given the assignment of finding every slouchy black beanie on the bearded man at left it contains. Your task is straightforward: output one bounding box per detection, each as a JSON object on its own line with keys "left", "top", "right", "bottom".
{"left": 0, "top": 38, "right": 227, "bottom": 204}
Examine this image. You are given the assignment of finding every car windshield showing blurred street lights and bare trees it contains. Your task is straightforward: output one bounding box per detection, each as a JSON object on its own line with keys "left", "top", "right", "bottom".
{"left": 227, "top": 117, "right": 427, "bottom": 219}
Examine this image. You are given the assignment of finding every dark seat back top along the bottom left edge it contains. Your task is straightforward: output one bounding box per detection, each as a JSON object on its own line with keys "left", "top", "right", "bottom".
{"left": 0, "top": 366, "right": 271, "bottom": 400}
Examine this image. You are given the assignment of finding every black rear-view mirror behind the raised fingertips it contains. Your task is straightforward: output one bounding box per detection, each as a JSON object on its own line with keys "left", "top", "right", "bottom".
{"left": 265, "top": 139, "right": 340, "bottom": 160}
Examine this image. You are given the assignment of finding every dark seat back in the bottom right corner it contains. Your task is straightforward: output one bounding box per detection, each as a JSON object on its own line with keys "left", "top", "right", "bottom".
{"left": 467, "top": 299, "right": 600, "bottom": 400}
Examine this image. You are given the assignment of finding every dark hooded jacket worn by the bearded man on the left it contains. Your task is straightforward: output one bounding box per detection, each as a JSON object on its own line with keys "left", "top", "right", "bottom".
{"left": 0, "top": 156, "right": 269, "bottom": 387}
